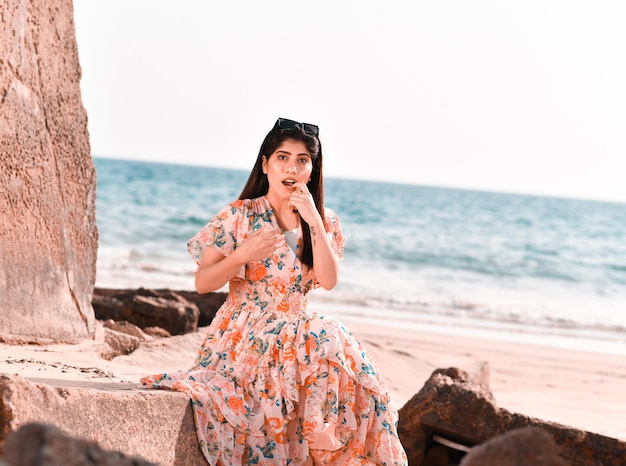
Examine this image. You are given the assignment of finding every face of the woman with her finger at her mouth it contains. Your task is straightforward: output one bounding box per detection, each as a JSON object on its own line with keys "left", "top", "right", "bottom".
{"left": 263, "top": 139, "right": 313, "bottom": 196}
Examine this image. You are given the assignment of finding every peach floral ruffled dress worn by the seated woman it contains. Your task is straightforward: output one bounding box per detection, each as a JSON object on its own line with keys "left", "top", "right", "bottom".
{"left": 141, "top": 197, "right": 407, "bottom": 466}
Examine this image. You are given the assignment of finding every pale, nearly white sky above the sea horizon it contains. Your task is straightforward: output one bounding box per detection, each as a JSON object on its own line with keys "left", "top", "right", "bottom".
{"left": 74, "top": 0, "right": 626, "bottom": 202}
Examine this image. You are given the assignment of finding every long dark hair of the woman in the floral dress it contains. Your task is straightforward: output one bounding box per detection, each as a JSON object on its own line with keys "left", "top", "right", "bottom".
{"left": 239, "top": 118, "right": 324, "bottom": 267}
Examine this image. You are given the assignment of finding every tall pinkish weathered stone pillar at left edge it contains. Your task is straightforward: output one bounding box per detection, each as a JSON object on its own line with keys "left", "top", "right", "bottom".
{"left": 0, "top": 0, "right": 98, "bottom": 342}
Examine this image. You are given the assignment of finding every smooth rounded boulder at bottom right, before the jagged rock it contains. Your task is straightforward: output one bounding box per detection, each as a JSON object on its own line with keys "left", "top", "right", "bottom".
{"left": 460, "top": 427, "right": 567, "bottom": 466}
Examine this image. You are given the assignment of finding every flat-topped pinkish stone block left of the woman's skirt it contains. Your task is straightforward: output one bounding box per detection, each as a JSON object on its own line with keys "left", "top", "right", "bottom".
{"left": 0, "top": 374, "right": 207, "bottom": 466}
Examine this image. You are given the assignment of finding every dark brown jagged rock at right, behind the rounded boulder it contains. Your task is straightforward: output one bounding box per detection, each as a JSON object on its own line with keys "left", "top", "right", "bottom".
{"left": 398, "top": 368, "right": 626, "bottom": 466}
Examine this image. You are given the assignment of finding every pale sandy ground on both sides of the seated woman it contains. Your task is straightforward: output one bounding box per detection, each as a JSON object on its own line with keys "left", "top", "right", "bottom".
{"left": 0, "top": 318, "right": 626, "bottom": 440}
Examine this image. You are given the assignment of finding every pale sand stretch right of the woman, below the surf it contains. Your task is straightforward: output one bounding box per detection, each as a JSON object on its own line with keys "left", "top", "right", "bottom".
{"left": 342, "top": 317, "right": 626, "bottom": 440}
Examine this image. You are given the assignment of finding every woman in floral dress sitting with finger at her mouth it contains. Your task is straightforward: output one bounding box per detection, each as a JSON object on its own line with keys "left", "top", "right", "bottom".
{"left": 142, "top": 118, "right": 406, "bottom": 466}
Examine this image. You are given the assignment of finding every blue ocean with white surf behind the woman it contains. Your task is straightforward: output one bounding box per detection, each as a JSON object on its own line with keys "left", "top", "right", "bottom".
{"left": 94, "top": 157, "right": 626, "bottom": 355}
